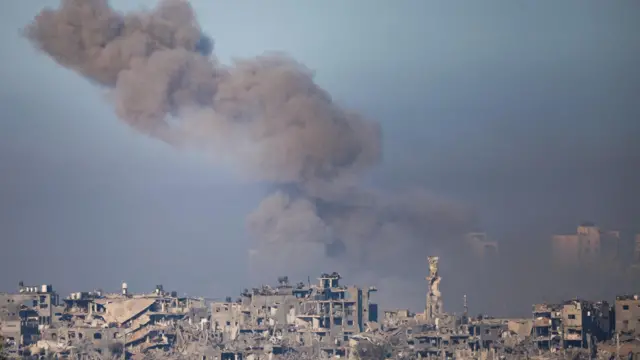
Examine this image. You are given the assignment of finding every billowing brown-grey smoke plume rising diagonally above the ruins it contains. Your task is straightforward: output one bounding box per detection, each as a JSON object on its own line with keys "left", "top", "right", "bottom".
{"left": 25, "top": 0, "right": 470, "bottom": 306}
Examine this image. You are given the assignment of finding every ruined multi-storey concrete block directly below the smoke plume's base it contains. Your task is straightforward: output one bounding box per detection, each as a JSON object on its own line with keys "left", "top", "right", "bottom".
{"left": 211, "top": 273, "right": 378, "bottom": 355}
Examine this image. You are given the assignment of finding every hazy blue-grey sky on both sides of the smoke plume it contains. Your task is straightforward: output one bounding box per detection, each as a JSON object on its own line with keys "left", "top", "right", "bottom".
{"left": 0, "top": 0, "right": 640, "bottom": 310}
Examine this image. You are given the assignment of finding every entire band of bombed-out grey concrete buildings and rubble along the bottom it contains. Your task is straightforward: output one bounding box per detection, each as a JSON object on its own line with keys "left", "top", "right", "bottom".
{"left": 0, "top": 257, "right": 640, "bottom": 360}
